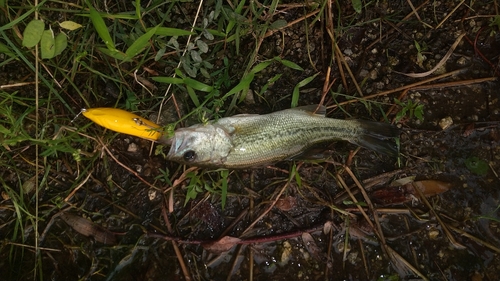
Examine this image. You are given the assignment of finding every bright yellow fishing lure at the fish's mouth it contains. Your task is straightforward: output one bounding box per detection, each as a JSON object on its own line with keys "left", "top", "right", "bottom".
{"left": 82, "top": 107, "right": 162, "bottom": 141}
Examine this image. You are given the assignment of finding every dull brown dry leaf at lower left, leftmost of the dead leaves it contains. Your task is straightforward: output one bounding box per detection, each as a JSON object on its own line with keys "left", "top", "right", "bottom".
{"left": 60, "top": 213, "right": 116, "bottom": 245}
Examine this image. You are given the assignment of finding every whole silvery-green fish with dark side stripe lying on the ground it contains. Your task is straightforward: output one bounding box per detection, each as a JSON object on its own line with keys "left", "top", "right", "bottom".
{"left": 166, "top": 105, "right": 400, "bottom": 166}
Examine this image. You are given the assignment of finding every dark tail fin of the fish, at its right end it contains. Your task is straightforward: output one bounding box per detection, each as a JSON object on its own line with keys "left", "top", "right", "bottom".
{"left": 351, "top": 120, "right": 400, "bottom": 156}
